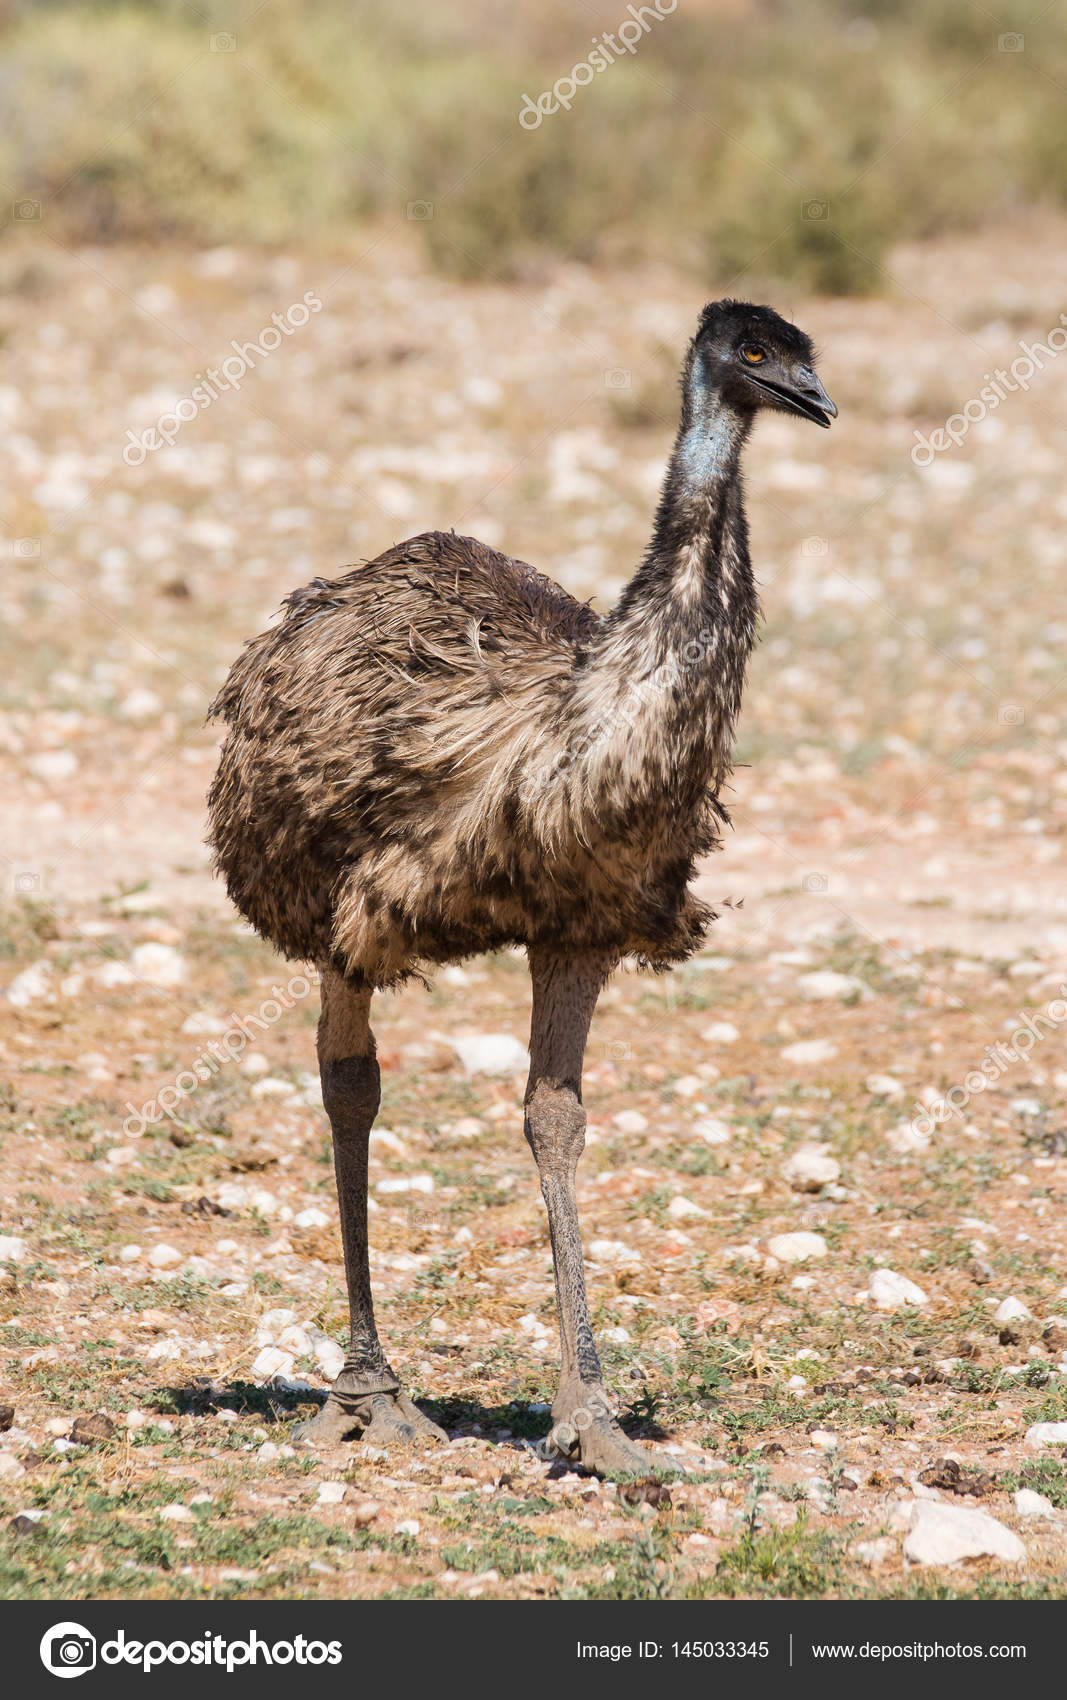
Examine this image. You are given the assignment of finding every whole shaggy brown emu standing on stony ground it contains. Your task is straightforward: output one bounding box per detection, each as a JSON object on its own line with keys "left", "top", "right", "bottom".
{"left": 209, "top": 301, "right": 838, "bottom": 1474}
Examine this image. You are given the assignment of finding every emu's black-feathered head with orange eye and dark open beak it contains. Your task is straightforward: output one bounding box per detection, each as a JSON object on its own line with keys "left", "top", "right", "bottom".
{"left": 683, "top": 301, "right": 838, "bottom": 427}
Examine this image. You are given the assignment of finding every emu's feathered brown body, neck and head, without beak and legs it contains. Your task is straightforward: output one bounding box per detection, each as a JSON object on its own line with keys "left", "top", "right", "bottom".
{"left": 209, "top": 303, "right": 833, "bottom": 988}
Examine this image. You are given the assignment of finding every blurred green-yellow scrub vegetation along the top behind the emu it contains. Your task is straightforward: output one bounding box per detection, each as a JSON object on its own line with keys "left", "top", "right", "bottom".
{"left": 0, "top": 0, "right": 1067, "bottom": 294}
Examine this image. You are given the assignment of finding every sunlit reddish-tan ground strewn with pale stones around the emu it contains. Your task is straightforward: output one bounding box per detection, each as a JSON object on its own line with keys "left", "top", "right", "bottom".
{"left": 0, "top": 228, "right": 1067, "bottom": 1598}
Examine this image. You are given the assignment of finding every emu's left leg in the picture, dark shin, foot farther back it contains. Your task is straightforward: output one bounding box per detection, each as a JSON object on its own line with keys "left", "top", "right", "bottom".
{"left": 294, "top": 969, "right": 447, "bottom": 1447}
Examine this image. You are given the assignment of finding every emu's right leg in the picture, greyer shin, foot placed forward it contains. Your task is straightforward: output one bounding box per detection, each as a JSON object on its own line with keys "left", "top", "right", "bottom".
{"left": 525, "top": 952, "right": 654, "bottom": 1476}
